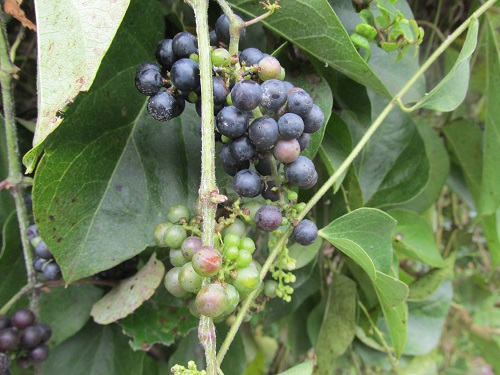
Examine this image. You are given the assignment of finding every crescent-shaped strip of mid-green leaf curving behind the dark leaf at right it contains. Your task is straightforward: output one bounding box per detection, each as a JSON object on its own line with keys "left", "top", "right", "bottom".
{"left": 394, "top": 121, "right": 450, "bottom": 213}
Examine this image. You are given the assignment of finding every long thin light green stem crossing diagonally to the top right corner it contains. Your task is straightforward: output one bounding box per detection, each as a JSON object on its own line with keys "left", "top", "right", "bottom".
{"left": 217, "top": 0, "right": 497, "bottom": 364}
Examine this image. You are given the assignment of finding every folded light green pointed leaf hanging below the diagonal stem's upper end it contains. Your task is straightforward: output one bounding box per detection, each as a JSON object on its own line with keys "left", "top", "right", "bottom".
{"left": 411, "top": 19, "right": 480, "bottom": 112}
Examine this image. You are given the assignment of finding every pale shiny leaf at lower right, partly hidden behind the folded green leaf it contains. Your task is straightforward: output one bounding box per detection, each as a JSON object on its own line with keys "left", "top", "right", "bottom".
{"left": 403, "top": 281, "right": 453, "bottom": 355}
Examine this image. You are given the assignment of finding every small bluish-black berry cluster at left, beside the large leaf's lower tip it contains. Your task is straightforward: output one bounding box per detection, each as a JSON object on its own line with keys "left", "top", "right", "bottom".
{"left": 26, "top": 225, "right": 62, "bottom": 281}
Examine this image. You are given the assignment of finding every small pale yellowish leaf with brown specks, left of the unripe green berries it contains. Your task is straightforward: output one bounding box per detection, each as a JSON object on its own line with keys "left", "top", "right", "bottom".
{"left": 90, "top": 253, "right": 165, "bottom": 324}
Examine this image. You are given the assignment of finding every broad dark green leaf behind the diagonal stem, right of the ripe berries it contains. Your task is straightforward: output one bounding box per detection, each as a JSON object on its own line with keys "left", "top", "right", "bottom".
{"left": 348, "top": 92, "right": 430, "bottom": 207}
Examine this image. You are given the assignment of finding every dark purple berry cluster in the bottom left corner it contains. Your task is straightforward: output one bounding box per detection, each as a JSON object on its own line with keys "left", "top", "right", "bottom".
{"left": 0, "top": 309, "right": 52, "bottom": 375}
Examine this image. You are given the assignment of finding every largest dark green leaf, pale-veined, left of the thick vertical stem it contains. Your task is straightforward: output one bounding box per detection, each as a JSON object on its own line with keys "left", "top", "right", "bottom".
{"left": 33, "top": 0, "right": 200, "bottom": 282}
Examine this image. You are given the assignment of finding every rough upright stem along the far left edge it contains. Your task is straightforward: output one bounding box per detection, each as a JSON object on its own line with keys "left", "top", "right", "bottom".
{"left": 0, "top": 4, "right": 40, "bottom": 316}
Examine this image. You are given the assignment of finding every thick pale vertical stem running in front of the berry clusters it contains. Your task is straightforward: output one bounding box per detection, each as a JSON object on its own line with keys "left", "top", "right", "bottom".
{"left": 186, "top": 0, "right": 220, "bottom": 375}
